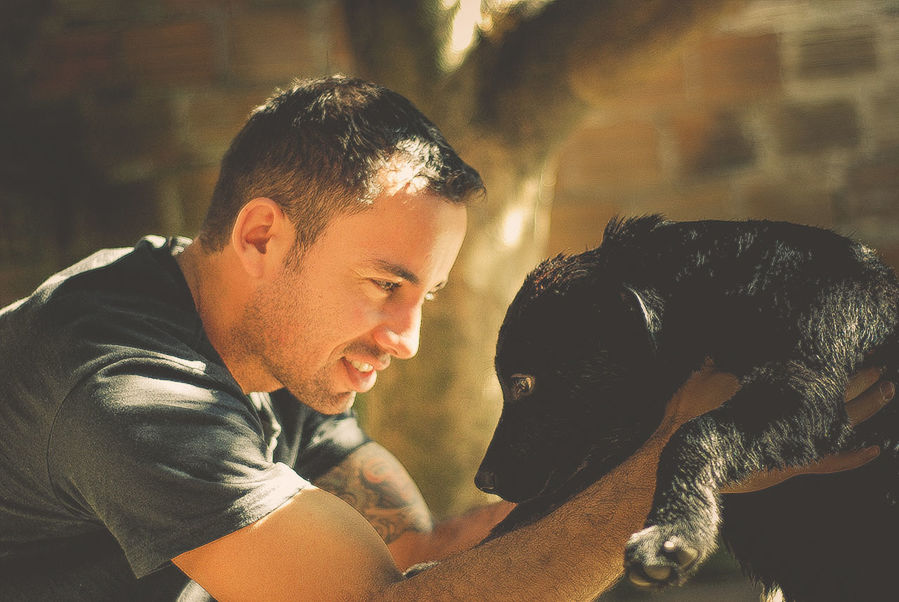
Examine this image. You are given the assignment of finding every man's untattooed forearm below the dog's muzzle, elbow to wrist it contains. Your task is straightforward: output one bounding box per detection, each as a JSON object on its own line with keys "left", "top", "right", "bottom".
{"left": 374, "top": 429, "right": 670, "bottom": 601}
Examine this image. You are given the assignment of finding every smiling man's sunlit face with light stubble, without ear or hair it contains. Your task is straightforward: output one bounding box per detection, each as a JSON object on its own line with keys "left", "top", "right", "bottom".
{"left": 241, "top": 189, "right": 466, "bottom": 414}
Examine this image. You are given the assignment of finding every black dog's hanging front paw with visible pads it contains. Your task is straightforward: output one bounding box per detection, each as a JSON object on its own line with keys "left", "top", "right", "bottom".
{"left": 624, "top": 526, "right": 701, "bottom": 589}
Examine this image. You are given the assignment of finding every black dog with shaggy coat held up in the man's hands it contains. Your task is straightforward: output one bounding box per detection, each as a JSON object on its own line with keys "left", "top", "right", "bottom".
{"left": 476, "top": 216, "right": 899, "bottom": 602}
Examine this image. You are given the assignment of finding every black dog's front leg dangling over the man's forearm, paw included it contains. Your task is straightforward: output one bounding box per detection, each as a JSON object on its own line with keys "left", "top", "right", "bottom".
{"left": 625, "top": 365, "right": 847, "bottom": 587}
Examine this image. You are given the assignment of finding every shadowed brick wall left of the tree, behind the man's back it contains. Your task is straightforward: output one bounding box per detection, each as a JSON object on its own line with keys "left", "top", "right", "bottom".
{"left": 0, "top": 0, "right": 352, "bottom": 305}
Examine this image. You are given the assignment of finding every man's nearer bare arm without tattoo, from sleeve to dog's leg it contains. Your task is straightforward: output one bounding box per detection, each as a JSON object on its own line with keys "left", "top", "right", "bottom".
{"left": 174, "top": 366, "right": 716, "bottom": 602}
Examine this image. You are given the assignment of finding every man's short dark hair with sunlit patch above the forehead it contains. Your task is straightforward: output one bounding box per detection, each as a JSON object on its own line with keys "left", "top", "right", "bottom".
{"left": 199, "top": 75, "right": 484, "bottom": 252}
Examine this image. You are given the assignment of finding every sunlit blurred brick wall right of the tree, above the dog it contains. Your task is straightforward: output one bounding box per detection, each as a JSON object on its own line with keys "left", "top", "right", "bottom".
{"left": 547, "top": 0, "right": 899, "bottom": 267}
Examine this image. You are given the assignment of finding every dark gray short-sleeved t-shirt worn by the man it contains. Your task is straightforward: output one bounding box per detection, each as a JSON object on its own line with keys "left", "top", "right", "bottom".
{"left": 0, "top": 237, "right": 367, "bottom": 592}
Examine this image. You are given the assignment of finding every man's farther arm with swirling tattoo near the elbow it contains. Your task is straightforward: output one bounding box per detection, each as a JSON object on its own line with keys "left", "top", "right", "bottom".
{"left": 314, "top": 442, "right": 514, "bottom": 570}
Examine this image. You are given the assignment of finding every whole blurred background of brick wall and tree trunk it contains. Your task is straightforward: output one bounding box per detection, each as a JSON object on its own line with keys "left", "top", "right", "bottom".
{"left": 0, "top": 0, "right": 899, "bottom": 601}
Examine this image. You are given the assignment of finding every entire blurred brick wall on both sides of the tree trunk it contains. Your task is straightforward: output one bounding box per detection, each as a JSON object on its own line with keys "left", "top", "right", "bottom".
{"left": 0, "top": 0, "right": 899, "bottom": 303}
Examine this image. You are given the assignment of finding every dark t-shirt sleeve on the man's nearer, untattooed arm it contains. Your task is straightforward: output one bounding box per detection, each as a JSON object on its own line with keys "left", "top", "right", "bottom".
{"left": 48, "top": 358, "right": 309, "bottom": 578}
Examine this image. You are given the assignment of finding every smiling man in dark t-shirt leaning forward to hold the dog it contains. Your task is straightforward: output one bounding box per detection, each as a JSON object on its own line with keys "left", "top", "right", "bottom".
{"left": 0, "top": 77, "right": 888, "bottom": 600}
